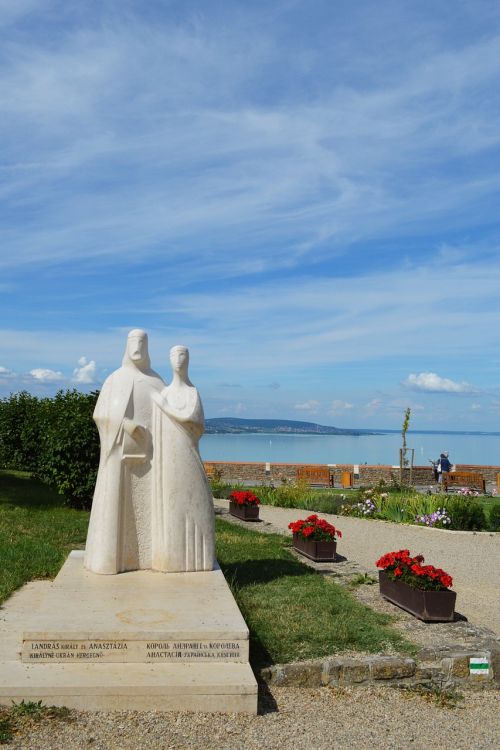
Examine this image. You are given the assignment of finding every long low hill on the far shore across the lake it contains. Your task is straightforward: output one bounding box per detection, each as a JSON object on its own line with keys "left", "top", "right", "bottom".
{"left": 205, "top": 417, "right": 376, "bottom": 435}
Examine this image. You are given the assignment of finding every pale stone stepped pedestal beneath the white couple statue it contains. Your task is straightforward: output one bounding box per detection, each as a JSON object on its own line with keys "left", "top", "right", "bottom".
{"left": 0, "top": 551, "right": 257, "bottom": 713}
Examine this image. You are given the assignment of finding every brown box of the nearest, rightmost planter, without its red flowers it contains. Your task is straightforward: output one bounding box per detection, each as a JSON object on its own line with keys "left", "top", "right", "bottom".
{"left": 378, "top": 570, "right": 457, "bottom": 622}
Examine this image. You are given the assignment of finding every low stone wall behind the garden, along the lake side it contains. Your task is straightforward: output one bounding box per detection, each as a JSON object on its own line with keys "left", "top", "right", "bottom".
{"left": 205, "top": 461, "right": 500, "bottom": 487}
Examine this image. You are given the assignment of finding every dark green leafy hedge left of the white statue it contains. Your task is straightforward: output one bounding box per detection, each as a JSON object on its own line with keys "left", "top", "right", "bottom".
{"left": 0, "top": 390, "right": 99, "bottom": 509}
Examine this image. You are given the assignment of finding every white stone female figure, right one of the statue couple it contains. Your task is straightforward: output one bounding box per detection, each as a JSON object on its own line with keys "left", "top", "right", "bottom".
{"left": 152, "top": 346, "right": 215, "bottom": 572}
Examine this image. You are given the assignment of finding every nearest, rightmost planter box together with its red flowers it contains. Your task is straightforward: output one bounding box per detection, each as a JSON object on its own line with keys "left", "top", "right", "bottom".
{"left": 376, "top": 550, "right": 457, "bottom": 622}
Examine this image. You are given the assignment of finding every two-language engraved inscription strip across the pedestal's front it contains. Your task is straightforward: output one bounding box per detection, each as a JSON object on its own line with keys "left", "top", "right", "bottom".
{"left": 22, "top": 640, "right": 248, "bottom": 663}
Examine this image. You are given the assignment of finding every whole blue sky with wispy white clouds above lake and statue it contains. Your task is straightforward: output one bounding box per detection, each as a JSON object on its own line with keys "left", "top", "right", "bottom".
{"left": 0, "top": 0, "right": 500, "bottom": 430}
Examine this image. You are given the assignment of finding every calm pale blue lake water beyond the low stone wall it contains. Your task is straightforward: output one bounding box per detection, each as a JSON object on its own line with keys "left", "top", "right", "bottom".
{"left": 200, "top": 432, "right": 500, "bottom": 466}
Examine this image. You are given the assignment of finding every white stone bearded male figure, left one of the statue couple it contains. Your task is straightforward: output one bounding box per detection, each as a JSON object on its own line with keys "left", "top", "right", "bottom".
{"left": 84, "top": 329, "right": 165, "bottom": 573}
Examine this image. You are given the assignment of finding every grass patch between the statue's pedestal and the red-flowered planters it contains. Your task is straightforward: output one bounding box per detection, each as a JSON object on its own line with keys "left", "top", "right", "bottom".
{"left": 217, "top": 520, "right": 413, "bottom": 665}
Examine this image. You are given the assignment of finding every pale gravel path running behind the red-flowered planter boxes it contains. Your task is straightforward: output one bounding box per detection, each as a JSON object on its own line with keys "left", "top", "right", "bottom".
{"left": 215, "top": 500, "right": 500, "bottom": 634}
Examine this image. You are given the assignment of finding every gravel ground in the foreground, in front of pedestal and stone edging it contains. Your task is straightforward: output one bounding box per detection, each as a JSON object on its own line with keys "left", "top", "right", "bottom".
{"left": 6, "top": 688, "right": 500, "bottom": 750}
